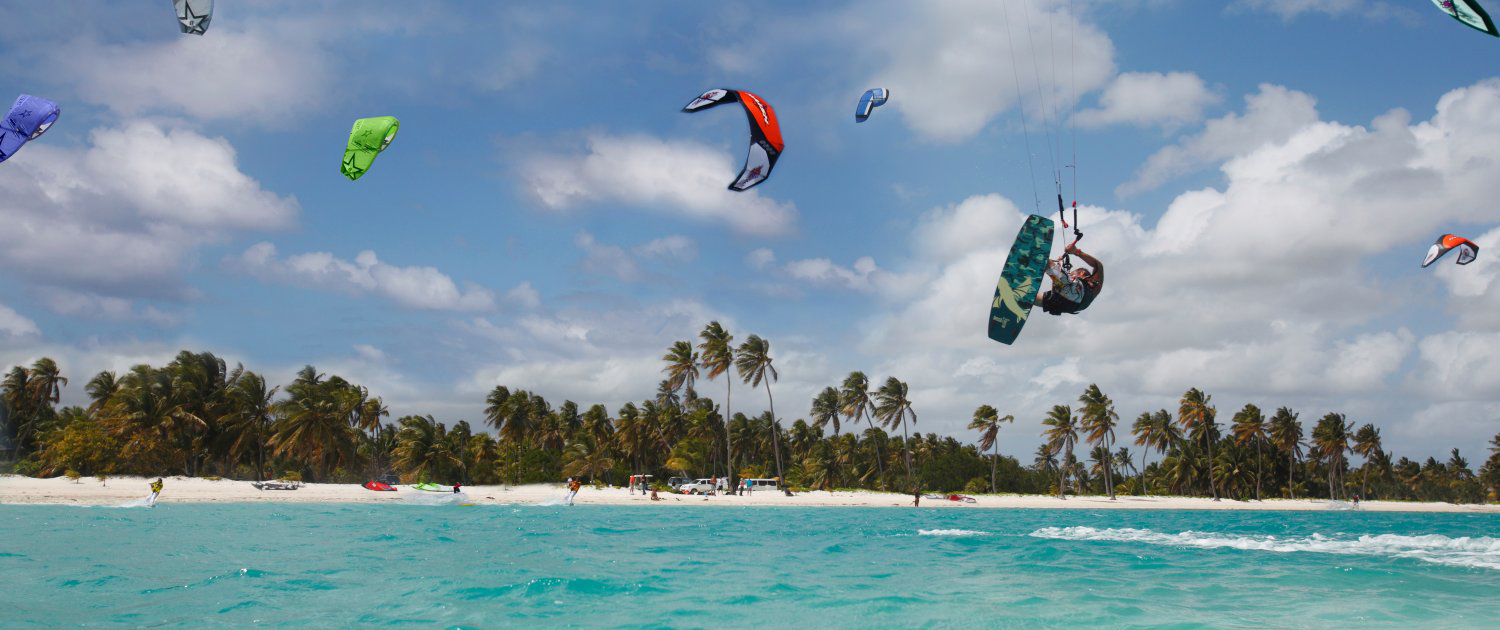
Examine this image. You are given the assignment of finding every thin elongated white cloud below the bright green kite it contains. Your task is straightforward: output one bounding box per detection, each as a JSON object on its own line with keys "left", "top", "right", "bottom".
{"left": 227, "top": 243, "right": 495, "bottom": 311}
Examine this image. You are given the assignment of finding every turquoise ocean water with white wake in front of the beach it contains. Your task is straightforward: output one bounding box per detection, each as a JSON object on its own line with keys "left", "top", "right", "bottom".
{"left": 0, "top": 503, "right": 1500, "bottom": 629}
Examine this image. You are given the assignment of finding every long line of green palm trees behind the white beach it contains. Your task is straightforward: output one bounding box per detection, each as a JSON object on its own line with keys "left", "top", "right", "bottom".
{"left": 0, "top": 321, "right": 1500, "bottom": 503}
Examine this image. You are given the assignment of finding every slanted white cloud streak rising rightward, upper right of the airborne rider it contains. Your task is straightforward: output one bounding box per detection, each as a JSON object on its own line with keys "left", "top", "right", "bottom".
{"left": 1115, "top": 84, "right": 1317, "bottom": 195}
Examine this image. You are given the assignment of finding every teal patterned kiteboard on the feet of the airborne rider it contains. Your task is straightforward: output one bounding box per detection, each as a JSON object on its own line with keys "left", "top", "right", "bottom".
{"left": 990, "top": 215, "right": 1052, "bottom": 345}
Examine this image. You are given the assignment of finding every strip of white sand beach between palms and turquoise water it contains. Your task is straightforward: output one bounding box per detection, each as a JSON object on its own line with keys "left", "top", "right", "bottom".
{"left": 0, "top": 476, "right": 1500, "bottom": 513}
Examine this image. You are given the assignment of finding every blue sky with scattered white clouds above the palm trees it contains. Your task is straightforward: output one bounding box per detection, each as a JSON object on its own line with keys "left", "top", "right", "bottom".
{"left": 0, "top": 0, "right": 1500, "bottom": 459}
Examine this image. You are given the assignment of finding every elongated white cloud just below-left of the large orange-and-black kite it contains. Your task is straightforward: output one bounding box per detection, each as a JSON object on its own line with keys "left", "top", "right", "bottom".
{"left": 521, "top": 135, "right": 797, "bottom": 236}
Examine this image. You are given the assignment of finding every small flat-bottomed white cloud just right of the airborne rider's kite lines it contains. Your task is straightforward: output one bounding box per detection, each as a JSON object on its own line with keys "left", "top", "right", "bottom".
{"left": 1074, "top": 72, "right": 1220, "bottom": 128}
